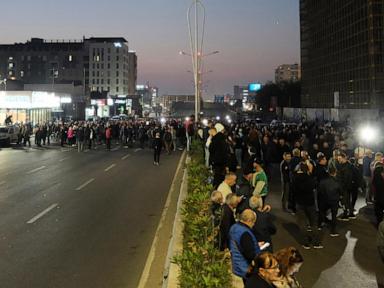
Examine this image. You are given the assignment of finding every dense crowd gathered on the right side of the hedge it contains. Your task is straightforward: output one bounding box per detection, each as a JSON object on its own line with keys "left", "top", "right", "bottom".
{"left": 197, "top": 122, "right": 384, "bottom": 287}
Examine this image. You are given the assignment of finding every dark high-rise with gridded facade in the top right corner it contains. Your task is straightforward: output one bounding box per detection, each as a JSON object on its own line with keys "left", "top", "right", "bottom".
{"left": 300, "top": 0, "right": 384, "bottom": 108}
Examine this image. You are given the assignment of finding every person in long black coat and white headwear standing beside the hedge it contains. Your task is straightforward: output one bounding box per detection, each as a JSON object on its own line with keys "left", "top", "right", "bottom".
{"left": 209, "top": 123, "right": 229, "bottom": 188}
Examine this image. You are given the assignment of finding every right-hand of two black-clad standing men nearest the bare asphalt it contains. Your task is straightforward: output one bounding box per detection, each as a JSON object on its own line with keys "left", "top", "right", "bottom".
{"left": 318, "top": 167, "right": 342, "bottom": 237}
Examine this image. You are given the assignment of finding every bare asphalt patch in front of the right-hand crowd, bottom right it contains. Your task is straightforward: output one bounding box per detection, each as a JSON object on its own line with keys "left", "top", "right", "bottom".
{"left": 267, "top": 181, "right": 384, "bottom": 288}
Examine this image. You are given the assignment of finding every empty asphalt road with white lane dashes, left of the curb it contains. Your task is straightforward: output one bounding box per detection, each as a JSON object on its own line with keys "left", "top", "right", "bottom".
{"left": 0, "top": 146, "right": 181, "bottom": 288}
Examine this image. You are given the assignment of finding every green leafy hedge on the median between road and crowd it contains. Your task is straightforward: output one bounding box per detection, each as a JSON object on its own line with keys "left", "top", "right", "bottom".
{"left": 173, "top": 142, "right": 231, "bottom": 288}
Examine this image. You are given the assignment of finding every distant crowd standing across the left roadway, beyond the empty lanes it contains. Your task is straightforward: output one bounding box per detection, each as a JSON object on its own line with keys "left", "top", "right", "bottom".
{"left": 5, "top": 120, "right": 193, "bottom": 165}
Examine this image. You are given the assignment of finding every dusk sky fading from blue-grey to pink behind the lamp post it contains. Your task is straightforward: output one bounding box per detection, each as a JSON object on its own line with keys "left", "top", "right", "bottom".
{"left": 0, "top": 0, "right": 300, "bottom": 96}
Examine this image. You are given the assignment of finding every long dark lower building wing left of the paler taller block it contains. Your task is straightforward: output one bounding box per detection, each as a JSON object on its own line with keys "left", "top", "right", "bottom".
{"left": 0, "top": 38, "right": 86, "bottom": 88}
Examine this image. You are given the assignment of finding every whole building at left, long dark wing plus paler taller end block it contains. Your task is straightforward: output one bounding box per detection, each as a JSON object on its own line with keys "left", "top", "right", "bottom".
{"left": 0, "top": 37, "right": 137, "bottom": 96}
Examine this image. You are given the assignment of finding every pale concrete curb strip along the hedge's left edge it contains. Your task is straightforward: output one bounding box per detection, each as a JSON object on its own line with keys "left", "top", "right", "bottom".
{"left": 162, "top": 156, "right": 191, "bottom": 288}
